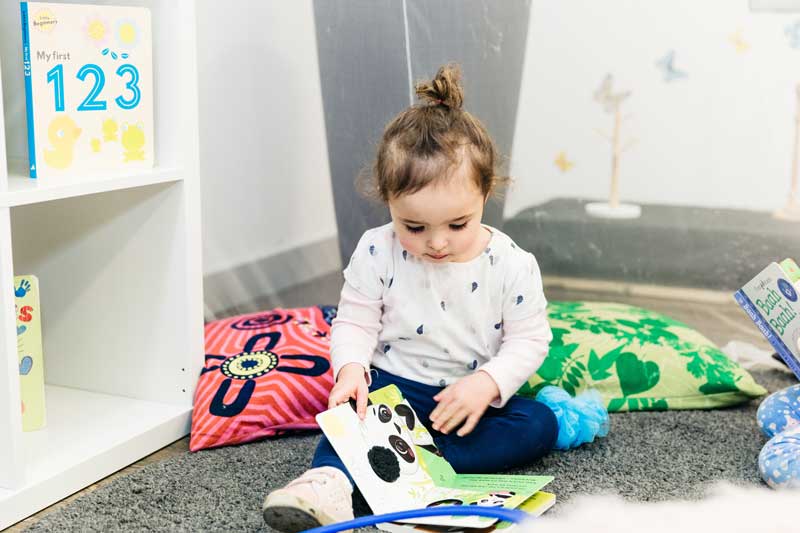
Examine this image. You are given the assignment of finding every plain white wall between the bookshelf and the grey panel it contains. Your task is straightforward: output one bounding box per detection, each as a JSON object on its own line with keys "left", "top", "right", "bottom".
{"left": 197, "top": 0, "right": 339, "bottom": 278}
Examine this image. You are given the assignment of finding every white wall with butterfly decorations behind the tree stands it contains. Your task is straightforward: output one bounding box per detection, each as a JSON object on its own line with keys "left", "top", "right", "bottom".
{"left": 505, "top": 0, "right": 800, "bottom": 216}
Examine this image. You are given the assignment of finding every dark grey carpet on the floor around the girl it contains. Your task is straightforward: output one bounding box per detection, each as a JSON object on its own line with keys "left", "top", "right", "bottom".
{"left": 26, "top": 371, "right": 796, "bottom": 532}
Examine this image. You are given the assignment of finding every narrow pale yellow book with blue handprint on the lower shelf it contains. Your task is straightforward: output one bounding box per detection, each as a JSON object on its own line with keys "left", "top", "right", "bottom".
{"left": 14, "top": 276, "right": 45, "bottom": 431}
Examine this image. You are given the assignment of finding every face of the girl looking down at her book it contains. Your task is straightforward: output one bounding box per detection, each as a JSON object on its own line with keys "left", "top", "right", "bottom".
{"left": 389, "top": 165, "right": 488, "bottom": 263}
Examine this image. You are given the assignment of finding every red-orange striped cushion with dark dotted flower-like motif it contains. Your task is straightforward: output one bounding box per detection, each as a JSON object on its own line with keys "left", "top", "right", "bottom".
{"left": 189, "top": 307, "right": 336, "bottom": 451}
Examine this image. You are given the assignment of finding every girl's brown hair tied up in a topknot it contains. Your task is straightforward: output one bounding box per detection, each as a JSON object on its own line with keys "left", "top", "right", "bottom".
{"left": 360, "top": 64, "right": 507, "bottom": 202}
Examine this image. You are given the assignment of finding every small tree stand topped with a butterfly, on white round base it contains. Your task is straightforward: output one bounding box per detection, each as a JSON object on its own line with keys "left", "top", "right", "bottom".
{"left": 586, "top": 74, "right": 642, "bottom": 218}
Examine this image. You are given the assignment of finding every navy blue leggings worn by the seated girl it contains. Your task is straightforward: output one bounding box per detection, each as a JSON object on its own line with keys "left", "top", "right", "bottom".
{"left": 311, "top": 368, "right": 558, "bottom": 486}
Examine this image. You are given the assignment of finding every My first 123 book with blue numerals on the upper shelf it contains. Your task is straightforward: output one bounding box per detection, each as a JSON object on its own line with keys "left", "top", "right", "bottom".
{"left": 20, "top": 2, "right": 154, "bottom": 178}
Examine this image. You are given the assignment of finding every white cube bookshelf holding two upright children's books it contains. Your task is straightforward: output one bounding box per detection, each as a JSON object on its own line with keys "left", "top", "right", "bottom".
{"left": 0, "top": 0, "right": 203, "bottom": 529}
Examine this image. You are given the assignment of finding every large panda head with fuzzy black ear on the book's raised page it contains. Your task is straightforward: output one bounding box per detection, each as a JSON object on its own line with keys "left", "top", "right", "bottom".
{"left": 350, "top": 394, "right": 442, "bottom": 483}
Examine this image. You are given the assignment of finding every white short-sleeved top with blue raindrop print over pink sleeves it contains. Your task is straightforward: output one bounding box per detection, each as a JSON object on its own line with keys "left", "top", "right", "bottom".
{"left": 351, "top": 220, "right": 537, "bottom": 386}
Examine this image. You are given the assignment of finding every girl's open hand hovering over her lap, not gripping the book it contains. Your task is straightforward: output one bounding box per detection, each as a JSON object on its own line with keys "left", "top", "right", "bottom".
{"left": 430, "top": 371, "right": 500, "bottom": 437}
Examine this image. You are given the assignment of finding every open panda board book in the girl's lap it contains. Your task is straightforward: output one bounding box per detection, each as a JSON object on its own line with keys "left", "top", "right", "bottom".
{"left": 316, "top": 385, "right": 553, "bottom": 528}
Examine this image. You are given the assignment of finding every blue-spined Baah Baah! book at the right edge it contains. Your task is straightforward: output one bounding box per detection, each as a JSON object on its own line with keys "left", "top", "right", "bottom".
{"left": 734, "top": 263, "right": 800, "bottom": 379}
